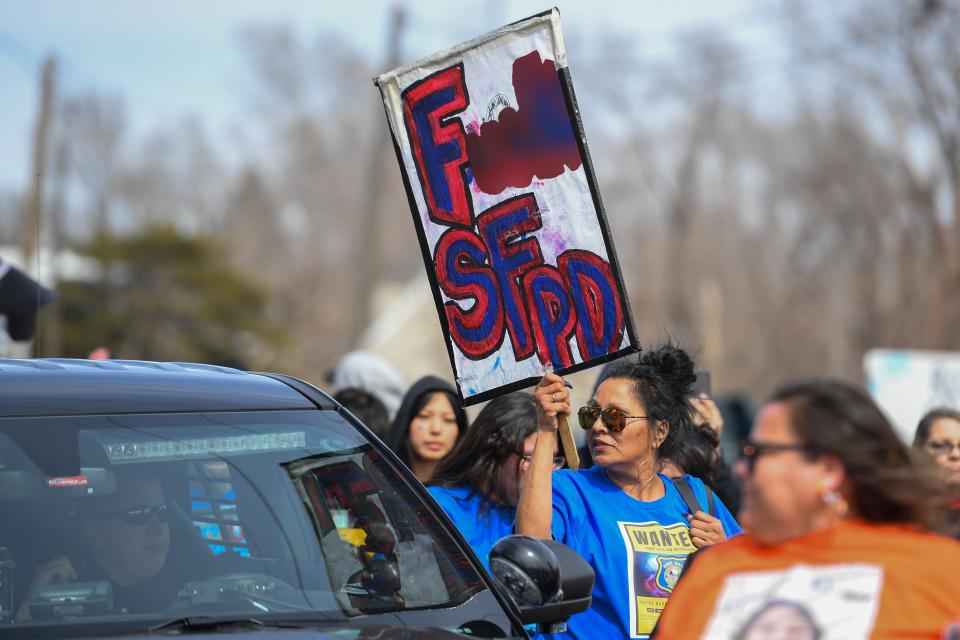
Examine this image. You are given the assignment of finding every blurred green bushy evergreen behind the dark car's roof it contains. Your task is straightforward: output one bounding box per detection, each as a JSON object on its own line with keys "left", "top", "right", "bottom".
{"left": 57, "top": 224, "right": 289, "bottom": 363}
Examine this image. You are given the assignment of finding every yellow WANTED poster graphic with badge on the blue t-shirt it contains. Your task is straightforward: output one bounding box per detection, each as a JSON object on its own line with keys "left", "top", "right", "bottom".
{"left": 618, "top": 522, "right": 696, "bottom": 638}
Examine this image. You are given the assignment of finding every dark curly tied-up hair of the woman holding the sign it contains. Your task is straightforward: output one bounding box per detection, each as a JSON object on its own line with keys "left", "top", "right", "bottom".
{"left": 596, "top": 342, "right": 697, "bottom": 458}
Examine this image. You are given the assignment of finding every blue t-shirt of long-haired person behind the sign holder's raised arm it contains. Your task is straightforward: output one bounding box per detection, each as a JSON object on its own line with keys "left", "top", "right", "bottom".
{"left": 427, "top": 487, "right": 517, "bottom": 572}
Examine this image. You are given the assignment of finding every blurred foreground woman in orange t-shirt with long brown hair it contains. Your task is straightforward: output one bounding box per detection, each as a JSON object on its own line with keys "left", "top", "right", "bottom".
{"left": 656, "top": 380, "right": 960, "bottom": 639}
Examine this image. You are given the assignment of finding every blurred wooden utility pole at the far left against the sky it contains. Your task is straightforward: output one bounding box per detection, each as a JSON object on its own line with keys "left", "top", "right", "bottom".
{"left": 20, "top": 56, "right": 57, "bottom": 276}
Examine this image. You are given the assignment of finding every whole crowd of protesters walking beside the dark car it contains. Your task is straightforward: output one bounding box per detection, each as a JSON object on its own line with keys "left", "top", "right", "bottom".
{"left": 336, "top": 344, "right": 960, "bottom": 638}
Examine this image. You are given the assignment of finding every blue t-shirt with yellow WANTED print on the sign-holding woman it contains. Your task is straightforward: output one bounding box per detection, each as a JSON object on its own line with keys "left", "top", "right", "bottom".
{"left": 552, "top": 466, "right": 740, "bottom": 640}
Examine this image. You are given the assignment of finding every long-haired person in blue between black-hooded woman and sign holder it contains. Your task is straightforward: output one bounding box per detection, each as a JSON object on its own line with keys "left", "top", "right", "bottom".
{"left": 429, "top": 392, "right": 564, "bottom": 566}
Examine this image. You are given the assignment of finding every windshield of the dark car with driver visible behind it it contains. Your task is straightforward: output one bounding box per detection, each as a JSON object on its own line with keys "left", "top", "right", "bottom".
{"left": 0, "top": 411, "right": 485, "bottom": 636}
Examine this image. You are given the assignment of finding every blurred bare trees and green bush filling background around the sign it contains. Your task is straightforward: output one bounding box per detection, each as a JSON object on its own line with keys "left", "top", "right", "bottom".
{"left": 0, "top": 0, "right": 960, "bottom": 400}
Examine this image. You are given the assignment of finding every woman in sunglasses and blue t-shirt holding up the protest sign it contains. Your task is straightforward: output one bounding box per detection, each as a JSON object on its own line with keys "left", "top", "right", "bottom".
{"left": 517, "top": 345, "right": 740, "bottom": 638}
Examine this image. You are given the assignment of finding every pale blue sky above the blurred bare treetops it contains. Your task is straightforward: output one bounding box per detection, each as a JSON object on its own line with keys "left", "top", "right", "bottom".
{"left": 0, "top": 0, "right": 779, "bottom": 192}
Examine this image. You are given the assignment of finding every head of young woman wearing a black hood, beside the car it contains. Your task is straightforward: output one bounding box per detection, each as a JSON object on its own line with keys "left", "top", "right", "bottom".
{"left": 387, "top": 376, "right": 467, "bottom": 483}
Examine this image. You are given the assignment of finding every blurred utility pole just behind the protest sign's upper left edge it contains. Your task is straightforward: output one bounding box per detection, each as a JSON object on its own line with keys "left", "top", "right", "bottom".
{"left": 348, "top": 5, "right": 406, "bottom": 349}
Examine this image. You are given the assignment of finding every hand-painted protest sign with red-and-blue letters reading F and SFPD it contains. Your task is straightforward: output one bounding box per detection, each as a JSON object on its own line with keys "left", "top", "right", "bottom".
{"left": 376, "top": 9, "right": 637, "bottom": 405}
